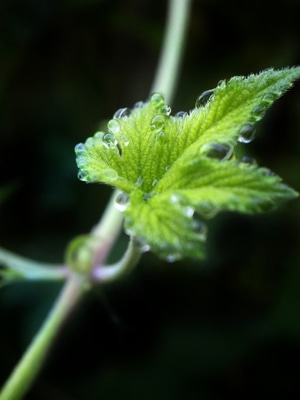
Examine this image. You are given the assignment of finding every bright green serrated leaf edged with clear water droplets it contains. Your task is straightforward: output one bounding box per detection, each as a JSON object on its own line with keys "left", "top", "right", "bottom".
{"left": 75, "top": 67, "right": 300, "bottom": 260}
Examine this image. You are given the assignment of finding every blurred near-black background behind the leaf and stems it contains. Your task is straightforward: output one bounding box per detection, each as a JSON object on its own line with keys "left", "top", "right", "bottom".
{"left": 0, "top": 0, "right": 300, "bottom": 400}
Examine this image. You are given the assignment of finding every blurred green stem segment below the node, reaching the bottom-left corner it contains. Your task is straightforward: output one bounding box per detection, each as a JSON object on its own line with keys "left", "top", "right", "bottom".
{"left": 0, "top": 275, "right": 82, "bottom": 400}
